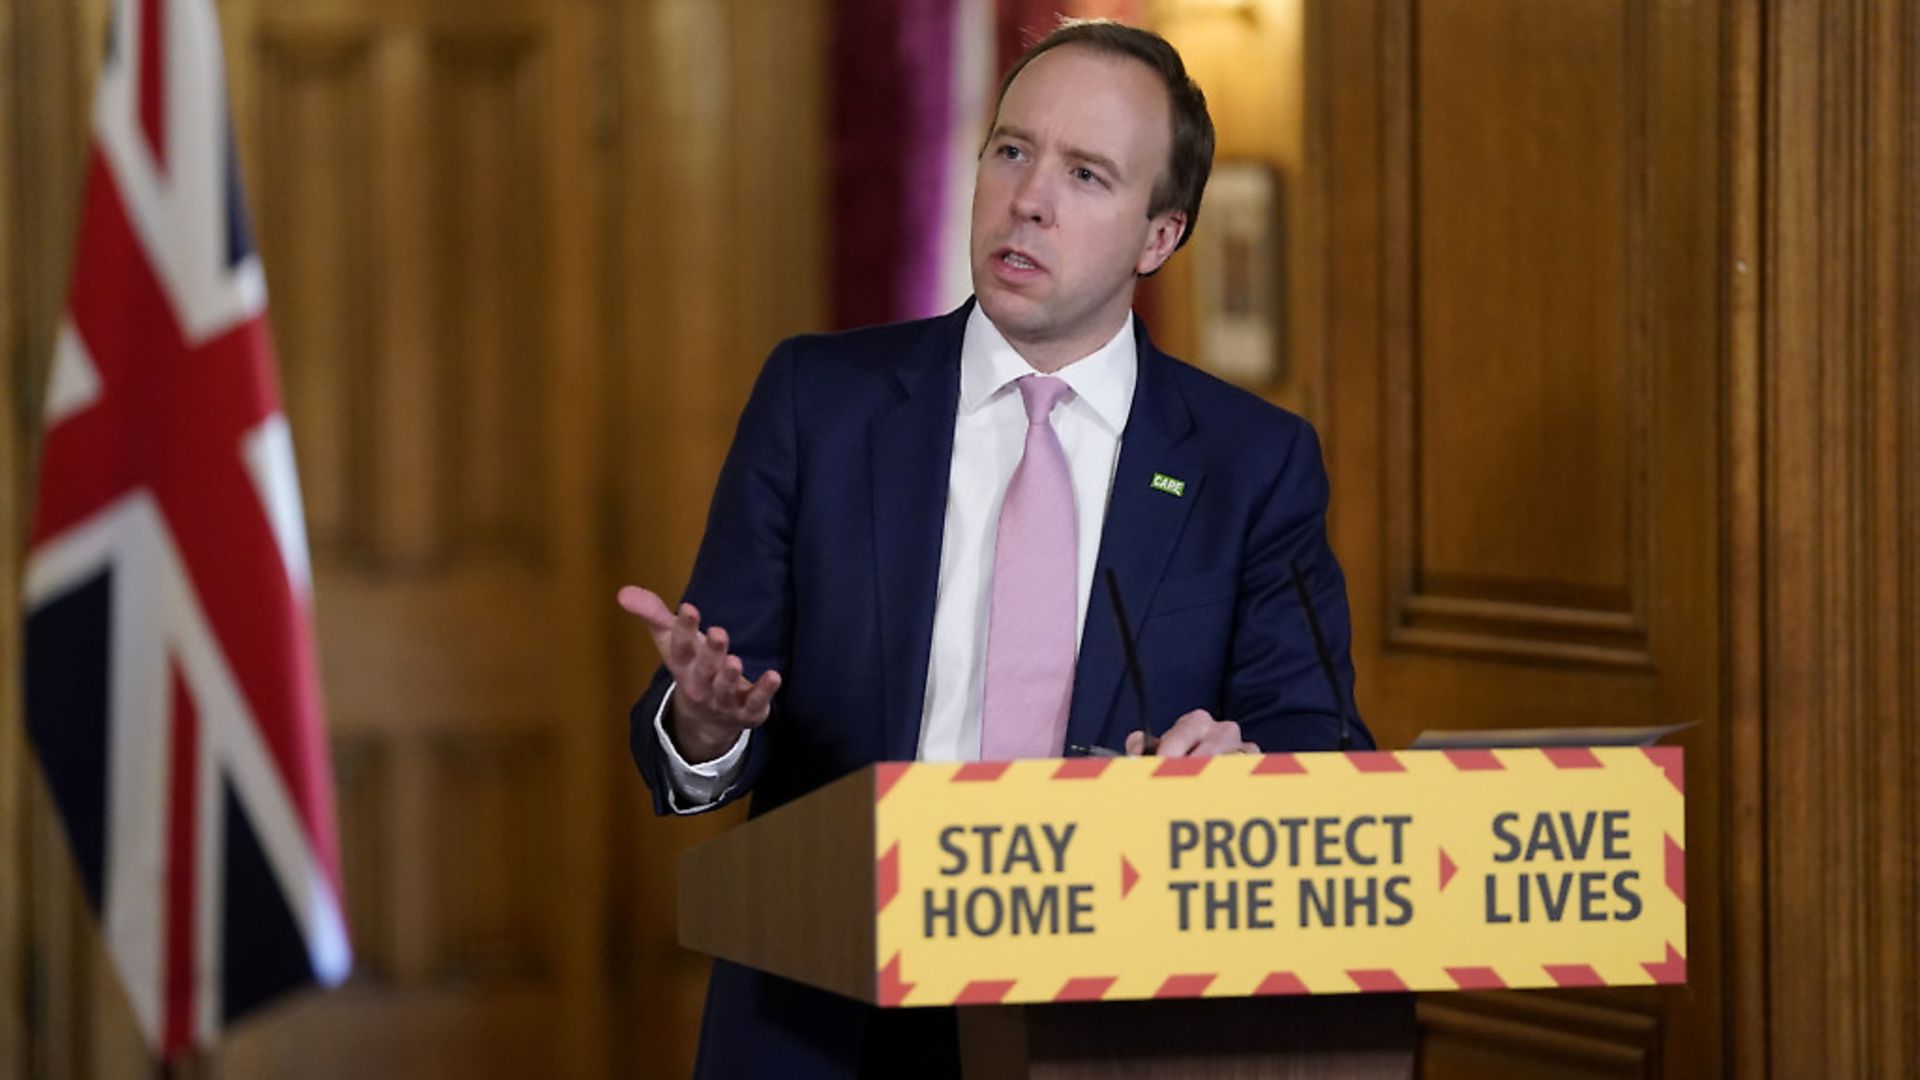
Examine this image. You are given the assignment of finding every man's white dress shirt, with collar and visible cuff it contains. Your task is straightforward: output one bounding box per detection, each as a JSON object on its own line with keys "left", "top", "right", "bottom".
{"left": 653, "top": 306, "right": 1139, "bottom": 813}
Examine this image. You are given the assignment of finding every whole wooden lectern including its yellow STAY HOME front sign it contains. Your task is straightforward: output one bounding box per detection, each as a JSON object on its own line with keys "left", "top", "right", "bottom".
{"left": 680, "top": 748, "right": 1686, "bottom": 1078}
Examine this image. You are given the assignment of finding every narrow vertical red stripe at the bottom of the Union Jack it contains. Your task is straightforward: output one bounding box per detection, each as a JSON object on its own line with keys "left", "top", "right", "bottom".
{"left": 161, "top": 667, "right": 200, "bottom": 1057}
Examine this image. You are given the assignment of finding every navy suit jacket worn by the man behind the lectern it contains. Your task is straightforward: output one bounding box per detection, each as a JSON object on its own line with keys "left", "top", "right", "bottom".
{"left": 632, "top": 304, "right": 1371, "bottom": 1076}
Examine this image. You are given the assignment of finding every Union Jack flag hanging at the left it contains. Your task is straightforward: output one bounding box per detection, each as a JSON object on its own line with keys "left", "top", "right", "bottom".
{"left": 25, "top": 0, "right": 351, "bottom": 1057}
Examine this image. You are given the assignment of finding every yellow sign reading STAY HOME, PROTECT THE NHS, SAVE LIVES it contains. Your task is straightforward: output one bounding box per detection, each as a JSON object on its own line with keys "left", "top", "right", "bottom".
{"left": 874, "top": 748, "right": 1686, "bottom": 1007}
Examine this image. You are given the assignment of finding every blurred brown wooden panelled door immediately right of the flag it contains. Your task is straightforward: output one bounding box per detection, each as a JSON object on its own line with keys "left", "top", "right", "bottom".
{"left": 217, "top": 0, "right": 611, "bottom": 1080}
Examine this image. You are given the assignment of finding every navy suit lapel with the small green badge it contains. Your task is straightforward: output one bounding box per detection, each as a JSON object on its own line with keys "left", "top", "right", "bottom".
{"left": 1068, "top": 323, "right": 1204, "bottom": 746}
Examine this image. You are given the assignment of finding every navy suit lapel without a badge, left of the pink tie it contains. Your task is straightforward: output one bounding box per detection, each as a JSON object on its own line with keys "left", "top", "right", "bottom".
{"left": 872, "top": 304, "right": 972, "bottom": 761}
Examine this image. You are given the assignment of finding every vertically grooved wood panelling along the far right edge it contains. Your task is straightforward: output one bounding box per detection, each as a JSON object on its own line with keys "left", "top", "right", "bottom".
{"left": 1757, "top": 0, "right": 1920, "bottom": 1076}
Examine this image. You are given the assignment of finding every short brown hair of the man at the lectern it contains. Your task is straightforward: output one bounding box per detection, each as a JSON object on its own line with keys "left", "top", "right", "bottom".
{"left": 993, "top": 19, "right": 1213, "bottom": 248}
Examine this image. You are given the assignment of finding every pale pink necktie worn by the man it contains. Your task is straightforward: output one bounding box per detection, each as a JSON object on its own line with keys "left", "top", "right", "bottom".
{"left": 979, "top": 375, "right": 1079, "bottom": 761}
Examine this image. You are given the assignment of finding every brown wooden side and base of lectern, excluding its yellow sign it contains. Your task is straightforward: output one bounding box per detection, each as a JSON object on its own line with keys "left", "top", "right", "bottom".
{"left": 680, "top": 767, "right": 1415, "bottom": 1080}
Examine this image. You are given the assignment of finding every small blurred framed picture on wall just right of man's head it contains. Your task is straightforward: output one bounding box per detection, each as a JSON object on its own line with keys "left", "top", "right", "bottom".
{"left": 1192, "top": 161, "right": 1286, "bottom": 390}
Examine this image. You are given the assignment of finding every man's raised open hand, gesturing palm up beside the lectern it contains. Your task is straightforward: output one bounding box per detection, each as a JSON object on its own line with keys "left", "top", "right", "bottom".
{"left": 620, "top": 584, "right": 780, "bottom": 763}
